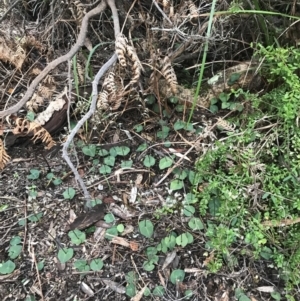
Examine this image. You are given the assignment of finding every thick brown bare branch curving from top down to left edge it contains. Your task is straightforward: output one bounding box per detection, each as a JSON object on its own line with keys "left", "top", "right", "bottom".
{"left": 0, "top": 1, "right": 106, "bottom": 118}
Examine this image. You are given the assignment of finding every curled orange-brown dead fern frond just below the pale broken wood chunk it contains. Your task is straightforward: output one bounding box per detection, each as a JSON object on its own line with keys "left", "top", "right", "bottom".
{"left": 12, "top": 118, "right": 55, "bottom": 149}
